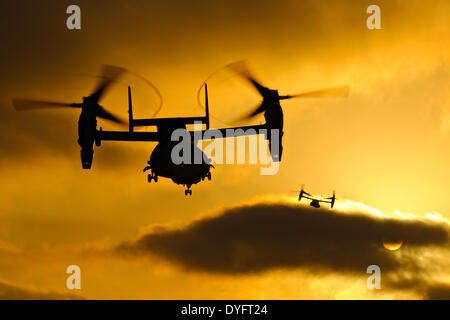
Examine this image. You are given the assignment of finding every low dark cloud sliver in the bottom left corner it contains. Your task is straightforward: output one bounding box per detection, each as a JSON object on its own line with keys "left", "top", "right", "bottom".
{"left": 0, "top": 280, "right": 83, "bottom": 300}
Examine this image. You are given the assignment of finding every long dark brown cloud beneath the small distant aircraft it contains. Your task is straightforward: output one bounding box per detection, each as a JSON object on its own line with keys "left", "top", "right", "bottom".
{"left": 117, "top": 201, "right": 449, "bottom": 274}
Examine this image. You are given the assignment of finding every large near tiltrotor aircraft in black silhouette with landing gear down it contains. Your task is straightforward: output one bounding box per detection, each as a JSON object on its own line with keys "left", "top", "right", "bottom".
{"left": 13, "top": 62, "right": 348, "bottom": 195}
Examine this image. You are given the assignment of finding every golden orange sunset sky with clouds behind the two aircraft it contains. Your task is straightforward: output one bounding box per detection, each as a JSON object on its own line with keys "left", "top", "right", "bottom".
{"left": 0, "top": 0, "right": 450, "bottom": 299}
